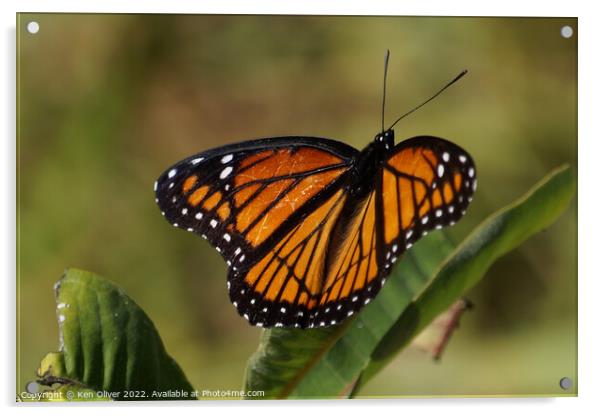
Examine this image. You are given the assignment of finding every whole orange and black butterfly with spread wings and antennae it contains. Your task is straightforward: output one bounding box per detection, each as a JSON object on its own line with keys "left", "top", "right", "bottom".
{"left": 155, "top": 52, "right": 477, "bottom": 328}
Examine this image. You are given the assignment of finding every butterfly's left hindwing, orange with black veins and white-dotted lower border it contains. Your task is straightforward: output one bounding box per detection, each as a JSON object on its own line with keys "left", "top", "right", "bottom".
{"left": 228, "top": 189, "right": 347, "bottom": 328}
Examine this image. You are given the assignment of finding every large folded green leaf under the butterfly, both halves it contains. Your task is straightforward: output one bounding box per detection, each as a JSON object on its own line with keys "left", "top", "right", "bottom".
{"left": 245, "top": 167, "right": 574, "bottom": 398}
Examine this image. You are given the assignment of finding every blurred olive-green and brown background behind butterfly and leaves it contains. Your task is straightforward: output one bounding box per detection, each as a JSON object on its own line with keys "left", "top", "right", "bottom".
{"left": 17, "top": 14, "right": 577, "bottom": 396}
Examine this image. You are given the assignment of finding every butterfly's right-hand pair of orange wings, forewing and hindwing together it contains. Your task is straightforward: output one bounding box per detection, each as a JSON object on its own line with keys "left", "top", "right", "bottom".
{"left": 313, "top": 136, "right": 476, "bottom": 326}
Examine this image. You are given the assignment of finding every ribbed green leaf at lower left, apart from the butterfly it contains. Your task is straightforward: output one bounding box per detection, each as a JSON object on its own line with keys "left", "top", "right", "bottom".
{"left": 38, "top": 269, "right": 194, "bottom": 400}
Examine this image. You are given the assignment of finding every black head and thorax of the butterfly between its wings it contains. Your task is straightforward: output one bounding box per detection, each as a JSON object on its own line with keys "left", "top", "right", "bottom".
{"left": 351, "top": 130, "right": 395, "bottom": 199}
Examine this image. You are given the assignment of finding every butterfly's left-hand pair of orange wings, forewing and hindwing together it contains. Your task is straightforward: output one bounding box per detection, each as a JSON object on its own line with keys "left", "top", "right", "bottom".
{"left": 155, "top": 137, "right": 357, "bottom": 325}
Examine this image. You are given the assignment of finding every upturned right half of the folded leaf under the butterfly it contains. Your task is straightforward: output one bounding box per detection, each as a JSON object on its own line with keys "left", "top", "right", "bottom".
{"left": 356, "top": 167, "right": 575, "bottom": 391}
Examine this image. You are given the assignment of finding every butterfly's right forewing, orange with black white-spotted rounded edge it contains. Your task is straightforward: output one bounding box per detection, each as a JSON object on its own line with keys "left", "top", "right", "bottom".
{"left": 381, "top": 136, "right": 477, "bottom": 270}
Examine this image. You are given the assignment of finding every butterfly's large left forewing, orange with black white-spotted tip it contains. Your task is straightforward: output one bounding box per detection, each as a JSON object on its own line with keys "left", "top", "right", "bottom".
{"left": 155, "top": 137, "right": 357, "bottom": 270}
